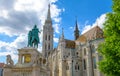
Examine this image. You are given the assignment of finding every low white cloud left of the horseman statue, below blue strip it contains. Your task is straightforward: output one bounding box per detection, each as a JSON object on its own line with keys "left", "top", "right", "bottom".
{"left": 0, "top": 34, "right": 27, "bottom": 60}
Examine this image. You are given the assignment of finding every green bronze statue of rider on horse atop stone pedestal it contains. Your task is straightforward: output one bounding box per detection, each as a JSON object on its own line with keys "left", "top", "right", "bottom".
{"left": 27, "top": 25, "right": 40, "bottom": 48}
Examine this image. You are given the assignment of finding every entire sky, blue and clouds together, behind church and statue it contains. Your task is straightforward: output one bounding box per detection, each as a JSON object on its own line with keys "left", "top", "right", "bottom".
{"left": 0, "top": 0, "right": 112, "bottom": 62}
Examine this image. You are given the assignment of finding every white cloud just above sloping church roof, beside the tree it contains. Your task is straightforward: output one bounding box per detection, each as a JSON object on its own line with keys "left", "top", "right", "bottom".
{"left": 82, "top": 14, "right": 106, "bottom": 34}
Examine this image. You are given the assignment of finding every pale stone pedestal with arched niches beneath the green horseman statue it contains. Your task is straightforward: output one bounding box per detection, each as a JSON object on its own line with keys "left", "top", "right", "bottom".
{"left": 3, "top": 47, "right": 49, "bottom": 76}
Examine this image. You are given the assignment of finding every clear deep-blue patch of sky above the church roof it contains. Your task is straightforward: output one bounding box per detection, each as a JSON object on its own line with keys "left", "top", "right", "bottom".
{"left": 57, "top": 0, "right": 112, "bottom": 39}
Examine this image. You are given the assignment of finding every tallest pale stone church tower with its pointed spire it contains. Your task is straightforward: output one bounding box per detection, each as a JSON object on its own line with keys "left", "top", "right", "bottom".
{"left": 42, "top": 4, "right": 53, "bottom": 57}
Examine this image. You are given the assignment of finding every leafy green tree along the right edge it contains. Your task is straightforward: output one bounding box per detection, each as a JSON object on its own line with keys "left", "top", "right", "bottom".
{"left": 98, "top": 0, "right": 120, "bottom": 76}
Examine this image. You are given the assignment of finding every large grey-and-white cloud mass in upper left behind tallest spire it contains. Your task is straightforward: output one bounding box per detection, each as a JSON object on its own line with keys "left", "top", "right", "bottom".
{"left": 0, "top": 0, "right": 63, "bottom": 36}
